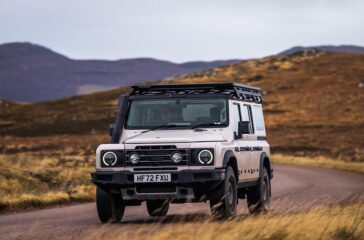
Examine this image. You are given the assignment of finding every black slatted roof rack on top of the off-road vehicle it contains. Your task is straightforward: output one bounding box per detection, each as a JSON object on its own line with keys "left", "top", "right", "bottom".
{"left": 130, "top": 83, "right": 263, "bottom": 103}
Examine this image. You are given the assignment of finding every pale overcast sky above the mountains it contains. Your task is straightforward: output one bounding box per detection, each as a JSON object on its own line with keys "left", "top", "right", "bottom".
{"left": 0, "top": 0, "right": 364, "bottom": 62}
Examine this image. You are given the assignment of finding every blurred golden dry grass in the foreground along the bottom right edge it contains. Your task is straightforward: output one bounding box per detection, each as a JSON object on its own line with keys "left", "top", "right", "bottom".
{"left": 85, "top": 204, "right": 364, "bottom": 240}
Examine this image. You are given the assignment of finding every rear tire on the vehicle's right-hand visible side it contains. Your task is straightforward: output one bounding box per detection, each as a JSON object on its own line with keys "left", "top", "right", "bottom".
{"left": 247, "top": 167, "right": 271, "bottom": 214}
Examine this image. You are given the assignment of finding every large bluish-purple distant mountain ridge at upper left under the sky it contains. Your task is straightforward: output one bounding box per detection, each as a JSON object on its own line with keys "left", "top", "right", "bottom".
{"left": 0, "top": 43, "right": 239, "bottom": 102}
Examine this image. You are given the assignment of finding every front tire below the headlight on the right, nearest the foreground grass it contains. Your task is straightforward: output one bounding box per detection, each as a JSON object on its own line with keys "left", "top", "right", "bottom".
{"left": 210, "top": 166, "right": 238, "bottom": 219}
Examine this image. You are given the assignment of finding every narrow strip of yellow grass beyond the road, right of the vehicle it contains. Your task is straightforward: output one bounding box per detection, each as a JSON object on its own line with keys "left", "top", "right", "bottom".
{"left": 272, "top": 154, "right": 364, "bottom": 174}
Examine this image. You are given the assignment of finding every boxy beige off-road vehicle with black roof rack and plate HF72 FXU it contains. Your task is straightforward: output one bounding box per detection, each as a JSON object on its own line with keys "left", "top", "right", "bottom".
{"left": 92, "top": 83, "right": 273, "bottom": 222}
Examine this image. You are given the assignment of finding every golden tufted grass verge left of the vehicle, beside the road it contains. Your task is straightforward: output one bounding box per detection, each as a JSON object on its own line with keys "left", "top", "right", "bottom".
{"left": 0, "top": 154, "right": 95, "bottom": 212}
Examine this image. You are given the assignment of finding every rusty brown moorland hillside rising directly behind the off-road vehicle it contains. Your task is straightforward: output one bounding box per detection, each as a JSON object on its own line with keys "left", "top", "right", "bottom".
{"left": 0, "top": 50, "right": 364, "bottom": 161}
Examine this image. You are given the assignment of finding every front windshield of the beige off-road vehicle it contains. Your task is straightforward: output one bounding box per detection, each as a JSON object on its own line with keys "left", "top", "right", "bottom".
{"left": 126, "top": 98, "right": 227, "bottom": 129}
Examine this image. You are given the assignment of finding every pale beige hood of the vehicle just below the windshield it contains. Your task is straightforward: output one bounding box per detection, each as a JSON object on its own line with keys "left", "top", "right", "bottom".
{"left": 124, "top": 129, "right": 226, "bottom": 144}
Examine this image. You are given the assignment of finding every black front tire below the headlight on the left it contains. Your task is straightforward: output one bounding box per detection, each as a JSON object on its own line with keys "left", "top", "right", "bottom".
{"left": 96, "top": 187, "right": 125, "bottom": 223}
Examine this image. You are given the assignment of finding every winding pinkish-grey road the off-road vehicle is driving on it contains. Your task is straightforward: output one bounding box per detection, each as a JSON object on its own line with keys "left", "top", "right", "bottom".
{"left": 0, "top": 165, "right": 364, "bottom": 239}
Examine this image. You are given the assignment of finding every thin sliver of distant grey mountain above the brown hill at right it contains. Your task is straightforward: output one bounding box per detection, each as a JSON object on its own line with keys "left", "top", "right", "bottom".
{"left": 279, "top": 45, "right": 364, "bottom": 55}
